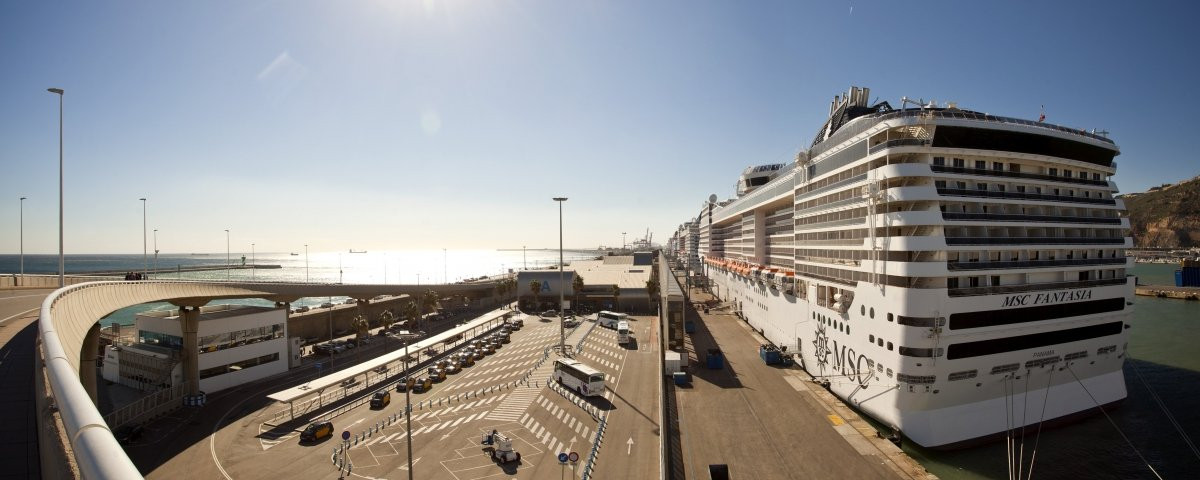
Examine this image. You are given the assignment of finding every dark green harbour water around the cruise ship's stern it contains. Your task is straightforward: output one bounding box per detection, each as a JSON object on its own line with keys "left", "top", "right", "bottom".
{"left": 905, "top": 264, "right": 1200, "bottom": 480}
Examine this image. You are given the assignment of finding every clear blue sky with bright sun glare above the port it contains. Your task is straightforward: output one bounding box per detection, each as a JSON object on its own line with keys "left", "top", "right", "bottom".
{"left": 0, "top": 0, "right": 1200, "bottom": 253}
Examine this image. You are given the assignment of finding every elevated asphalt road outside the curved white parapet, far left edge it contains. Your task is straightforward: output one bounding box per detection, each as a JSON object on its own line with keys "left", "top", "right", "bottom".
{"left": 0, "top": 289, "right": 53, "bottom": 479}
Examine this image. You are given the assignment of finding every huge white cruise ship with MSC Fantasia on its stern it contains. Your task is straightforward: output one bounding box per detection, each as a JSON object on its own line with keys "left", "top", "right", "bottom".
{"left": 668, "top": 88, "right": 1134, "bottom": 449}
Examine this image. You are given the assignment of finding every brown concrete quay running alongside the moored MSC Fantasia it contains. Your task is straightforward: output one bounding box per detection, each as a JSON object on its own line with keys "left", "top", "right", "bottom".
{"left": 666, "top": 289, "right": 936, "bottom": 480}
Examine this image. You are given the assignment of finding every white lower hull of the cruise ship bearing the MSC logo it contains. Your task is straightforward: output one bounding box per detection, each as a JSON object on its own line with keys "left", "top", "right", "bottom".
{"left": 708, "top": 268, "right": 1132, "bottom": 448}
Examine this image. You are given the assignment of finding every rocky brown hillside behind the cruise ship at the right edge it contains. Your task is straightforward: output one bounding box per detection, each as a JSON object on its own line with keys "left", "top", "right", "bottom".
{"left": 1121, "top": 176, "right": 1200, "bottom": 248}
